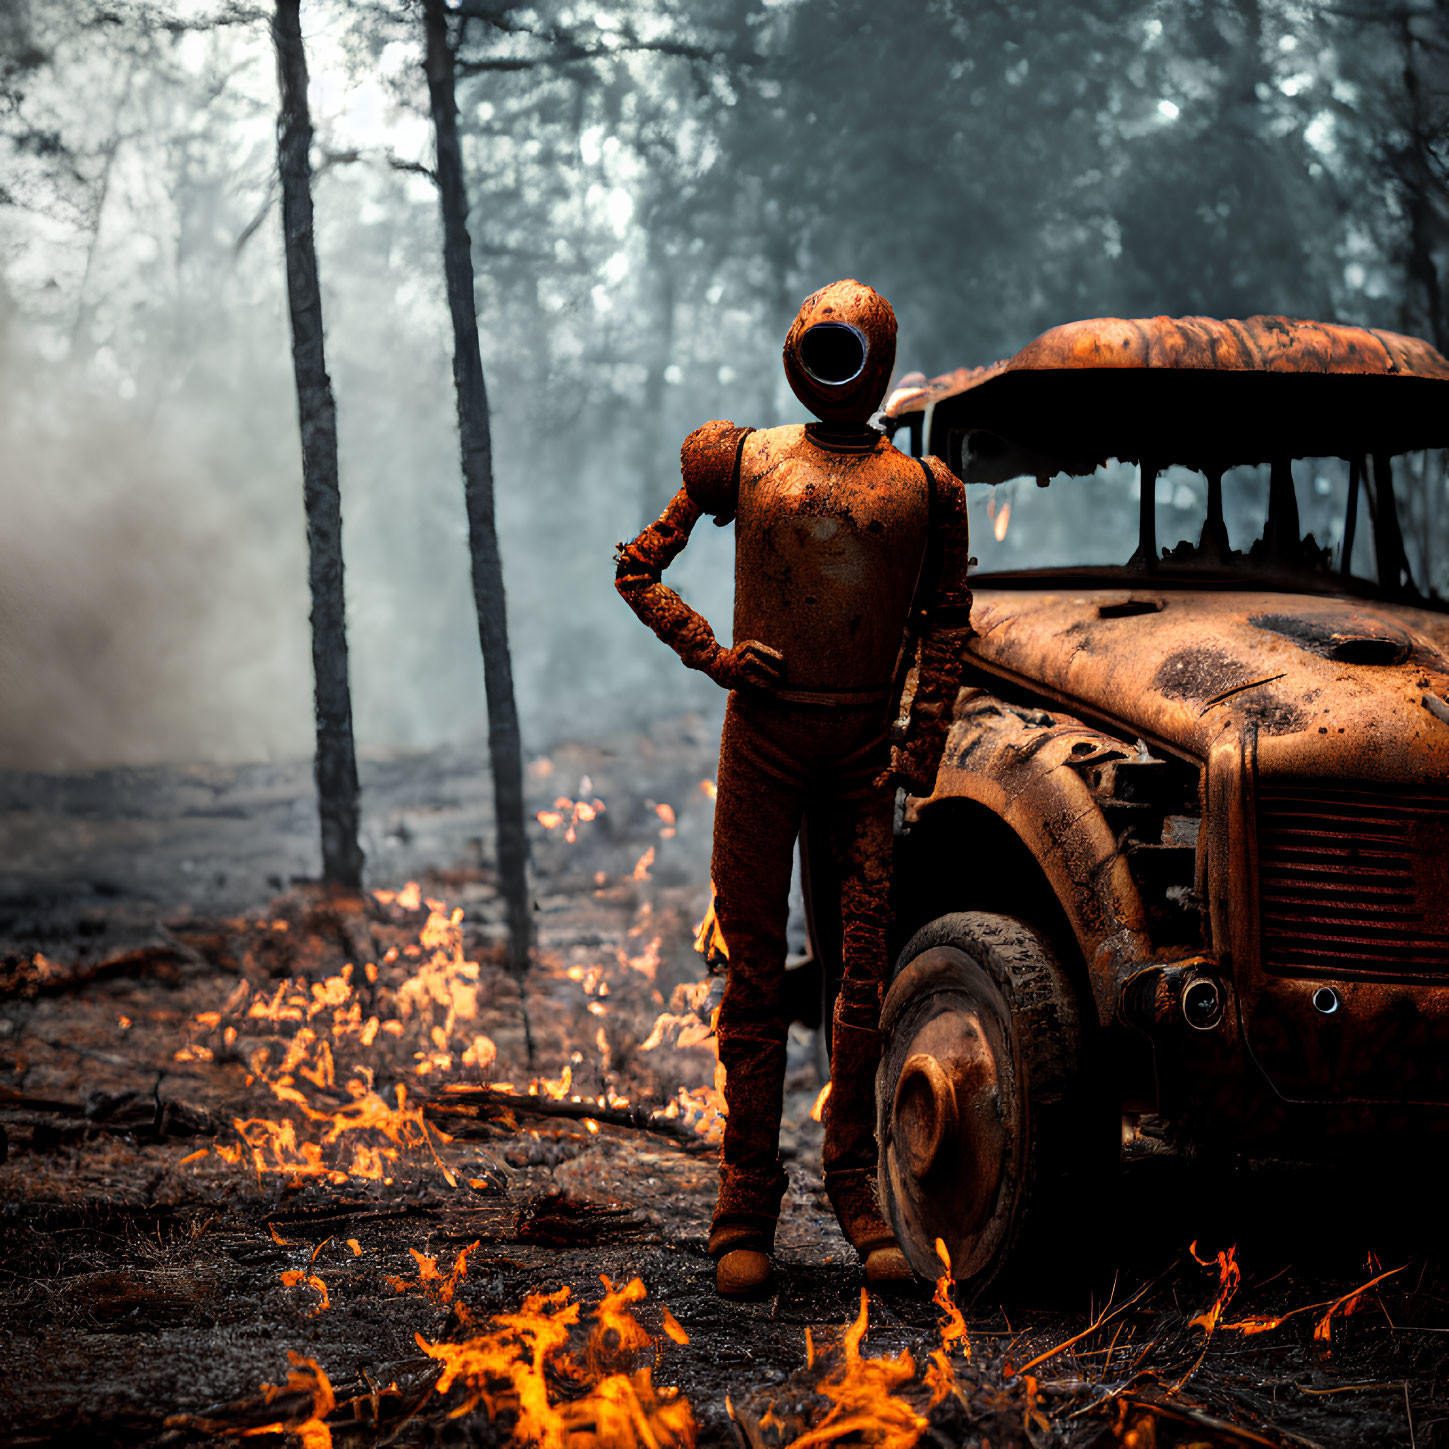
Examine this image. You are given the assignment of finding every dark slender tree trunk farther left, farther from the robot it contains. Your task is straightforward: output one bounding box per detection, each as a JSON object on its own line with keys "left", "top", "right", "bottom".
{"left": 272, "top": 0, "right": 362, "bottom": 891}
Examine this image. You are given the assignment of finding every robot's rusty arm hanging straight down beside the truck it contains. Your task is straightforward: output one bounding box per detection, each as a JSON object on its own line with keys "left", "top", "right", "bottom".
{"left": 891, "top": 456, "right": 975, "bottom": 796}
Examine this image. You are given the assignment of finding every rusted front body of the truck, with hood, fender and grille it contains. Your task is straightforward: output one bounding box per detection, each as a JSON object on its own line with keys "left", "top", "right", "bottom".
{"left": 911, "top": 587, "right": 1449, "bottom": 1124}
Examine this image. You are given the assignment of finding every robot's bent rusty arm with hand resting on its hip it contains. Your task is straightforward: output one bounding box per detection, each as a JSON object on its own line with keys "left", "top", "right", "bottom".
{"left": 614, "top": 422, "right": 772, "bottom": 690}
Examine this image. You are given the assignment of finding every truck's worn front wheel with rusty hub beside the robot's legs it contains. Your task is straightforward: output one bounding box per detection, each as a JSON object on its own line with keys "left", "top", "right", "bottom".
{"left": 877, "top": 911, "right": 1120, "bottom": 1301}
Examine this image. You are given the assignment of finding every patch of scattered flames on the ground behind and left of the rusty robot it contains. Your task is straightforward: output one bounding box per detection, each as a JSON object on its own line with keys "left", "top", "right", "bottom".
{"left": 175, "top": 778, "right": 725, "bottom": 1187}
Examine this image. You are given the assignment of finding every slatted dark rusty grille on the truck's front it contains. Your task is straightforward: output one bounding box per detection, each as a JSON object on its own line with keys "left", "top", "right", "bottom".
{"left": 1258, "top": 781, "right": 1449, "bottom": 980}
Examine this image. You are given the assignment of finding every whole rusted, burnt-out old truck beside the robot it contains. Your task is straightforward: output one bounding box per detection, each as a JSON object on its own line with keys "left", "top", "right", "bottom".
{"left": 840, "top": 317, "right": 1449, "bottom": 1290}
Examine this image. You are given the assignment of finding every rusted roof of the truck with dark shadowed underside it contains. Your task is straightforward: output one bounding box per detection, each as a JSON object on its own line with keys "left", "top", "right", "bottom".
{"left": 890, "top": 316, "right": 1449, "bottom": 483}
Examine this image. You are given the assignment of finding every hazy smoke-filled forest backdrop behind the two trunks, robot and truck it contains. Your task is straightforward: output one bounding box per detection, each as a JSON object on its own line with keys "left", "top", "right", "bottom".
{"left": 0, "top": 0, "right": 1449, "bottom": 767}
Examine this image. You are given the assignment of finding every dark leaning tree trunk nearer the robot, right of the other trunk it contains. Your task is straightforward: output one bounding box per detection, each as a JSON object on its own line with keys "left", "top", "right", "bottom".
{"left": 423, "top": 0, "right": 533, "bottom": 975}
